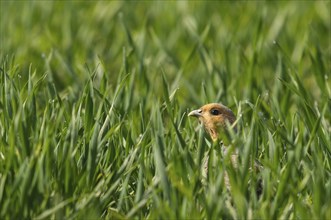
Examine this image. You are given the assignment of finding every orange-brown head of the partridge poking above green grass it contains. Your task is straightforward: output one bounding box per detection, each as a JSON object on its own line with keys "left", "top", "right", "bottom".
{"left": 188, "top": 103, "right": 236, "bottom": 140}
